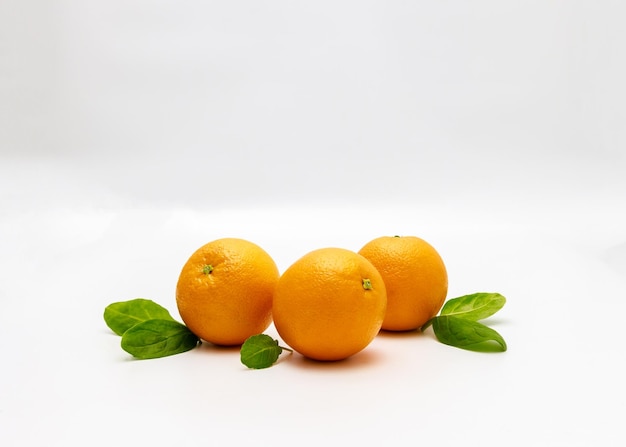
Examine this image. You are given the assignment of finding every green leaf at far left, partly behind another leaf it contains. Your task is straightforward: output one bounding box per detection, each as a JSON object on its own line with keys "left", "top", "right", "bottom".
{"left": 104, "top": 298, "right": 174, "bottom": 335}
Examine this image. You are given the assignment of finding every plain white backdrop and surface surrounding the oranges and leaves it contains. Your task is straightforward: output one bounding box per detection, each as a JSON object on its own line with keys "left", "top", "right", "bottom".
{"left": 0, "top": 0, "right": 626, "bottom": 446}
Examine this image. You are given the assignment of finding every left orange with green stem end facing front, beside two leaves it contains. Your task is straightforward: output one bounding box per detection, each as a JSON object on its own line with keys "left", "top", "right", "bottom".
{"left": 176, "top": 238, "right": 280, "bottom": 345}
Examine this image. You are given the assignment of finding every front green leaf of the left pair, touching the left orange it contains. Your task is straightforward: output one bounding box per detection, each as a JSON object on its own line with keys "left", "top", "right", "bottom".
{"left": 122, "top": 319, "right": 200, "bottom": 359}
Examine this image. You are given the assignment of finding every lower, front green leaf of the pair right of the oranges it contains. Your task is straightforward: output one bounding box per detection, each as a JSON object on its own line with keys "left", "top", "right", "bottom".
{"left": 432, "top": 316, "right": 507, "bottom": 352}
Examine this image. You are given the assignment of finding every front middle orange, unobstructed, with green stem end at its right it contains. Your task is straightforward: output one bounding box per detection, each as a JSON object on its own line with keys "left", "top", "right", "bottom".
{"left": 273, "top": 248, "right": 387, "bottom": 360}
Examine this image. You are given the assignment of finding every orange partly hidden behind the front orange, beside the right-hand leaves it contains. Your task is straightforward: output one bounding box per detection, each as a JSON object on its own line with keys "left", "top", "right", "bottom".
{"left": 359, "top": 236, "right": 448, "bottom": 331}
